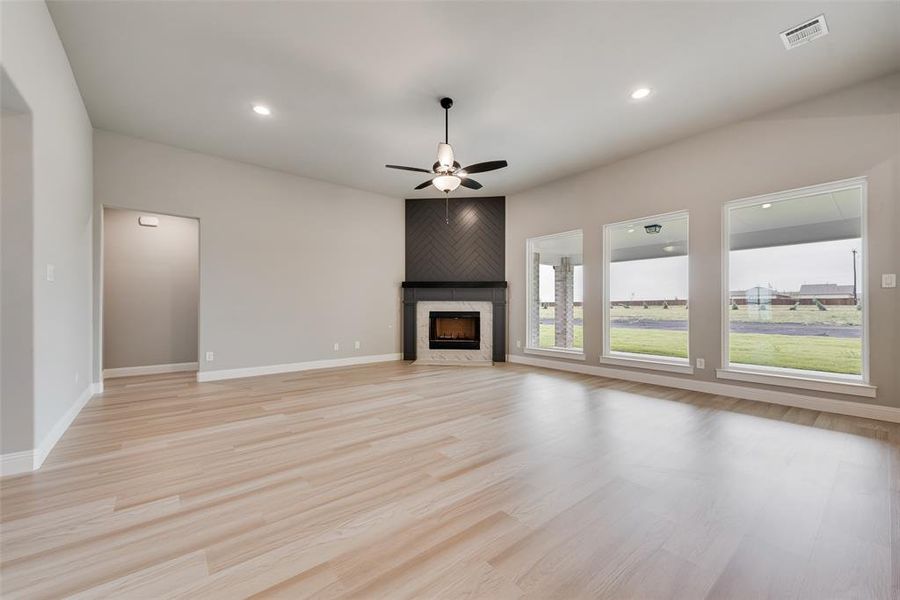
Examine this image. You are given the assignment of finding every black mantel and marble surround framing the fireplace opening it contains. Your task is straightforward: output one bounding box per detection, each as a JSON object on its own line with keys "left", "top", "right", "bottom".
{"left": 402, "top": 281, "right": 507, "bottom": 365}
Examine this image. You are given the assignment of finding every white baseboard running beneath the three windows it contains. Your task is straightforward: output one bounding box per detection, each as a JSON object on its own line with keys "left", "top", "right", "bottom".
{"left": 507, "top": 354, "right": 900, "bottom": 423}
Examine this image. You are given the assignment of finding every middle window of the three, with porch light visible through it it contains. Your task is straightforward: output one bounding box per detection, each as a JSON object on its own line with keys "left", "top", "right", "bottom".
{"left": 603, "top": 212, "right": 690, "bottom": 371}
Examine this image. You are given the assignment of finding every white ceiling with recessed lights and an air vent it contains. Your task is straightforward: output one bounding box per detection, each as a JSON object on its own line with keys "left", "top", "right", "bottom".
{"left": 50, "top": 0, "right": 900, "bottom": 197}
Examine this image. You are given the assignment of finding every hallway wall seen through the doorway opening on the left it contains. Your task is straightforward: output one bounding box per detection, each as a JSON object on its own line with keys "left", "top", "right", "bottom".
{"left": 103, "top": 208, "right": 200, "bottom": 369}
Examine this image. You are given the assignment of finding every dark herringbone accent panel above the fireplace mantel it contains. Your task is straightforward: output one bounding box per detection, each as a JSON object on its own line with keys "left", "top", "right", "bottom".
{"left": 406, "top": 196, "right": 506, "bottom": 281}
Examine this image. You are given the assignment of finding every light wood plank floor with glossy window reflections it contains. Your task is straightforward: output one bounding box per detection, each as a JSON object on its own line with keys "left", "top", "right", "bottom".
{"left": 0, "top": 363, "right": 900, "bottom": 600}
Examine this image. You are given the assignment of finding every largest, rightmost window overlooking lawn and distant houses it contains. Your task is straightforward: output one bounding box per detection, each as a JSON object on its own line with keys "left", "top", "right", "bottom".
{"left": 723, "top": 179, "right": 866, "bottom": 382}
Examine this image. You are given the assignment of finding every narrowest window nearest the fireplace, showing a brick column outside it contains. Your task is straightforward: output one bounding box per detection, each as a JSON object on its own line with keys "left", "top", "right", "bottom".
{"left": 525, "top": 230, "right": 584, "bottom": 358}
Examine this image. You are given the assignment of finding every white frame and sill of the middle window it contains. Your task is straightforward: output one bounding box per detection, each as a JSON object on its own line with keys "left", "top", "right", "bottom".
{"left": 600, "top": 209, "right": 694, "bottom": 374}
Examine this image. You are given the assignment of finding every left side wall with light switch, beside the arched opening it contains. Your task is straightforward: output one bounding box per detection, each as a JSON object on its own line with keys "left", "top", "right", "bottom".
{"left": 0, "top": 2, "right": 93, "bottom": 458}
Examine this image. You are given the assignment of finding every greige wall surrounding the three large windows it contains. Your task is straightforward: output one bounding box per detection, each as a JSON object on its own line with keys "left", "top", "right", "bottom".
{"left": 506, "top": 74, "right": 900, "bottom": 406}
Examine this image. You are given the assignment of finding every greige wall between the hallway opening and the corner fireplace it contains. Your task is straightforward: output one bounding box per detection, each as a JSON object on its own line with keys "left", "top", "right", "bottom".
{"left": 94, "top": 130, "right": 404, "bottom": 372}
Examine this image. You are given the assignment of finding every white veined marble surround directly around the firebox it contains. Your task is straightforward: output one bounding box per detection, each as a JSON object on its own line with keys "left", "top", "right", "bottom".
{"left": 416, "top": 300, "right": 494, "bottom": 365}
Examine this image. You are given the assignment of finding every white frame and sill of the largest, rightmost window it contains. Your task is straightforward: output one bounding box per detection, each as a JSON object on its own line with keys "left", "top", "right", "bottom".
{"left": 716, "top": 176, "right": 876, "bottom": 397}
